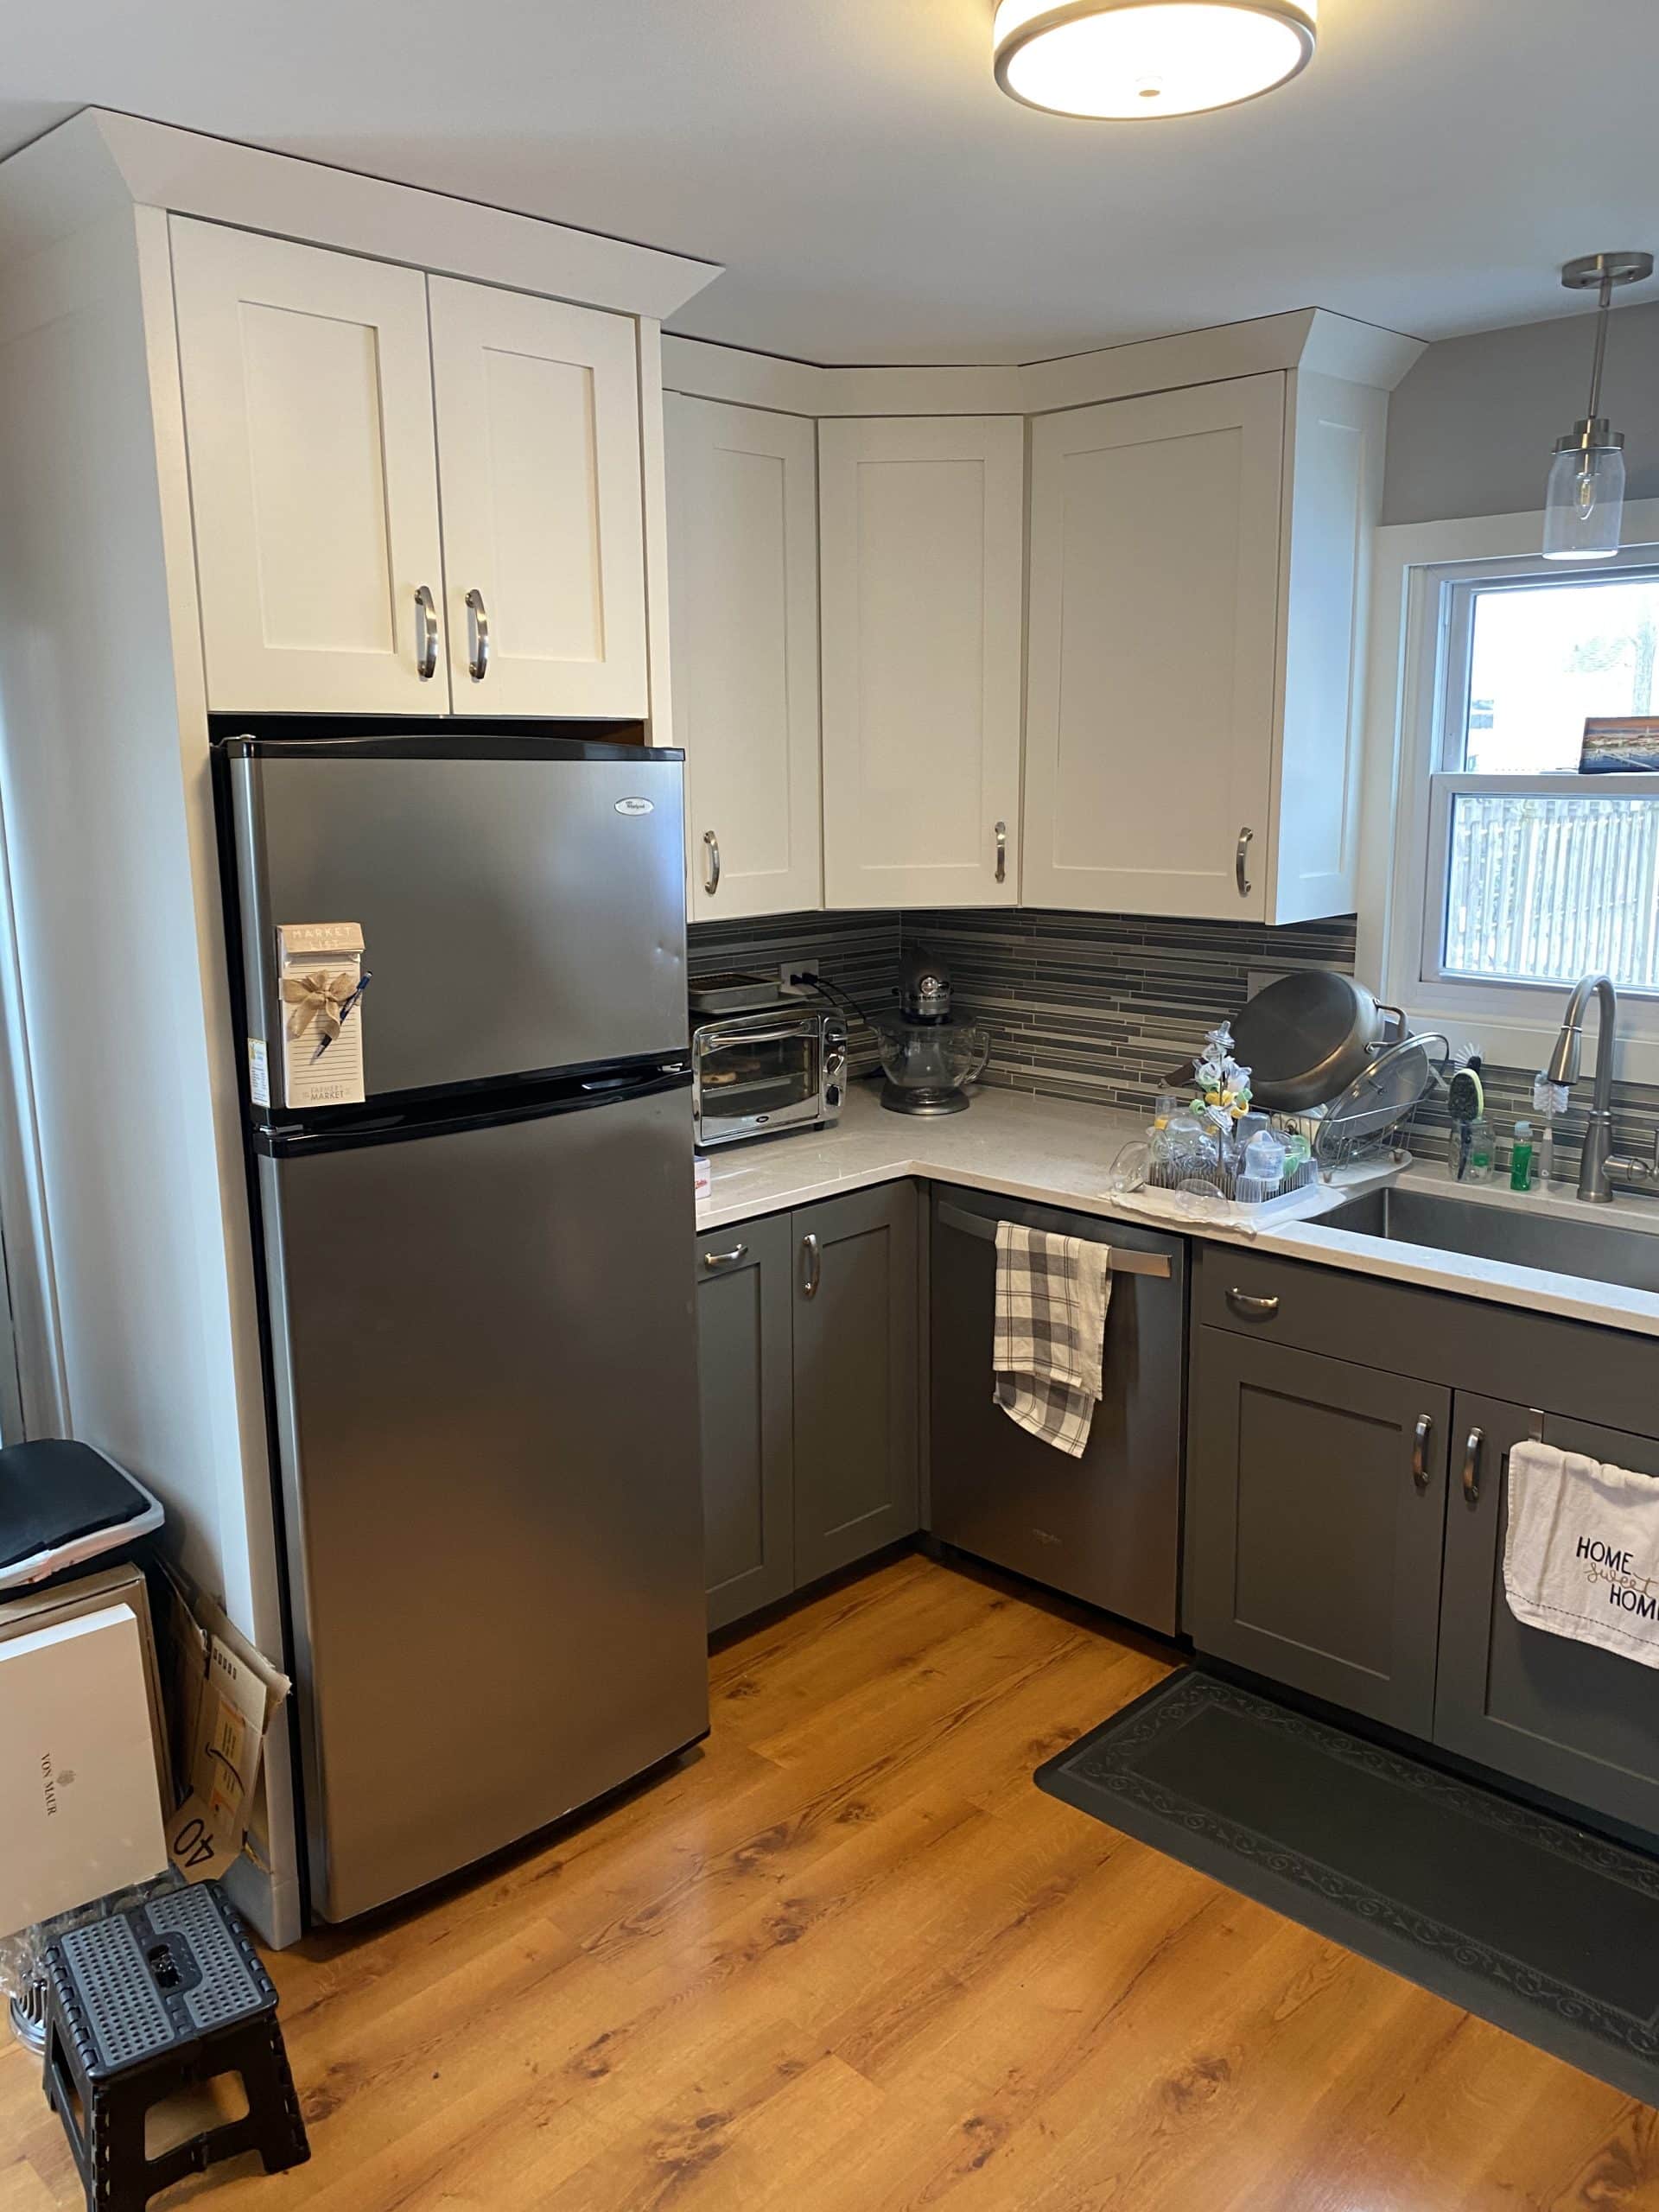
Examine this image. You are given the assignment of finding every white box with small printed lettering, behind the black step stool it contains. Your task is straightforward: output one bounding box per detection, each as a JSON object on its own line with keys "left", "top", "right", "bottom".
{"left": 0, "top": 1604, "right": 166, "bottom": 1931}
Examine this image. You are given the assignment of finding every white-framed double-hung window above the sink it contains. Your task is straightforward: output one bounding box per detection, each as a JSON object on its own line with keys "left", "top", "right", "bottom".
{"left": 1421, "top": 562, "right": 1659, "bottom": 995}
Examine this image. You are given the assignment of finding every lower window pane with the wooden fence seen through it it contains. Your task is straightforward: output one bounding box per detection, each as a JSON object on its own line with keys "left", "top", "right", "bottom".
{"left": 1442, "top": 791, "right": 1659, "bottom": 991}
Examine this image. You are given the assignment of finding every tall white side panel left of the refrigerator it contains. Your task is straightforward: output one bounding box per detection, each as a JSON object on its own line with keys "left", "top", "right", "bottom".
{"left": 0, "top": 214, "right": 272, "bottom": 1648}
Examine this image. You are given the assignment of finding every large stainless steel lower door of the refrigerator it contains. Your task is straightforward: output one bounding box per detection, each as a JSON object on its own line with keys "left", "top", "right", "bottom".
{"left": 259, "top": 1090, "right": 708, "bottom": 1920}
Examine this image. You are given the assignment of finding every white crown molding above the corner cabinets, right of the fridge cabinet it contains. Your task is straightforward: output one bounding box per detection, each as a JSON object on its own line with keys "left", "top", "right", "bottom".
{"left": 661, "top": 308, "right": 1425, "bottom": 420}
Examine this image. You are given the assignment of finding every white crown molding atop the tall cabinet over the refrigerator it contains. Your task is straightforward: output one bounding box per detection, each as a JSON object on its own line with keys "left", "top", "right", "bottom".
{"left": 0, "top": 108, "right": 721, "bottom": 321}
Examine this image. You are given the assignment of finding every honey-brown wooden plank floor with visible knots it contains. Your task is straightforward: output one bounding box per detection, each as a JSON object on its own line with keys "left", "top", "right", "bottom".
{"left": 0, "top": 1557, "right": 1659, "bottom": 2212}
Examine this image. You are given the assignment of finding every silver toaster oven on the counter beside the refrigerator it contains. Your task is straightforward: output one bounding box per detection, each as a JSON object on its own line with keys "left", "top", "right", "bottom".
{"left": 692, "top": 1007, "right": 847, "bottom": 1148}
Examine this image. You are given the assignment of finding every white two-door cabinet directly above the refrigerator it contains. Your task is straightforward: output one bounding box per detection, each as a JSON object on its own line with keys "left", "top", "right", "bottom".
{"left": 170, "top": 217, "right": 651, "bottom": 719}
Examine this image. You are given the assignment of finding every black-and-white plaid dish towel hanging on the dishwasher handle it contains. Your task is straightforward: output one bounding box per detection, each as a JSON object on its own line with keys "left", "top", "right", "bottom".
{"left": 991, "top": 1221, "right": 1113, "bottom": 1460}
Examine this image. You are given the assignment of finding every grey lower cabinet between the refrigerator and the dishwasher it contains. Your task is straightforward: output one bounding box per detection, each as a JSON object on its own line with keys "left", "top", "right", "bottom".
{"left": 695, "top": 1184, "right": 920, "bottom": 1628}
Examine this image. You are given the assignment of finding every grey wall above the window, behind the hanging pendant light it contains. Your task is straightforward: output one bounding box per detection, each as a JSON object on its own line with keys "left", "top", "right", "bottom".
{"left": 1382, "top": 285, "right": 1659, "bottom": 522}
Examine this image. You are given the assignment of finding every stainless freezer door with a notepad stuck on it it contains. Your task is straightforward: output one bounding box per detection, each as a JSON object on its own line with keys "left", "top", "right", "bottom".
{"left": 230, "top": 739, "right": 686, "bottom": 1109}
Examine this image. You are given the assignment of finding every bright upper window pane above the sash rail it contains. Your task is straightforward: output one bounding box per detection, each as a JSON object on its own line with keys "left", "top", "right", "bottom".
{"left": 1465, "top": 575, "right": 1659, "bottom": 777}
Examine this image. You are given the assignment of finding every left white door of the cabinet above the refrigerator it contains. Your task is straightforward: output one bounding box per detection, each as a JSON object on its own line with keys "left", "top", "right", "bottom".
{"left": 173, "top": 217, "right": 449, "bottom": 715}
